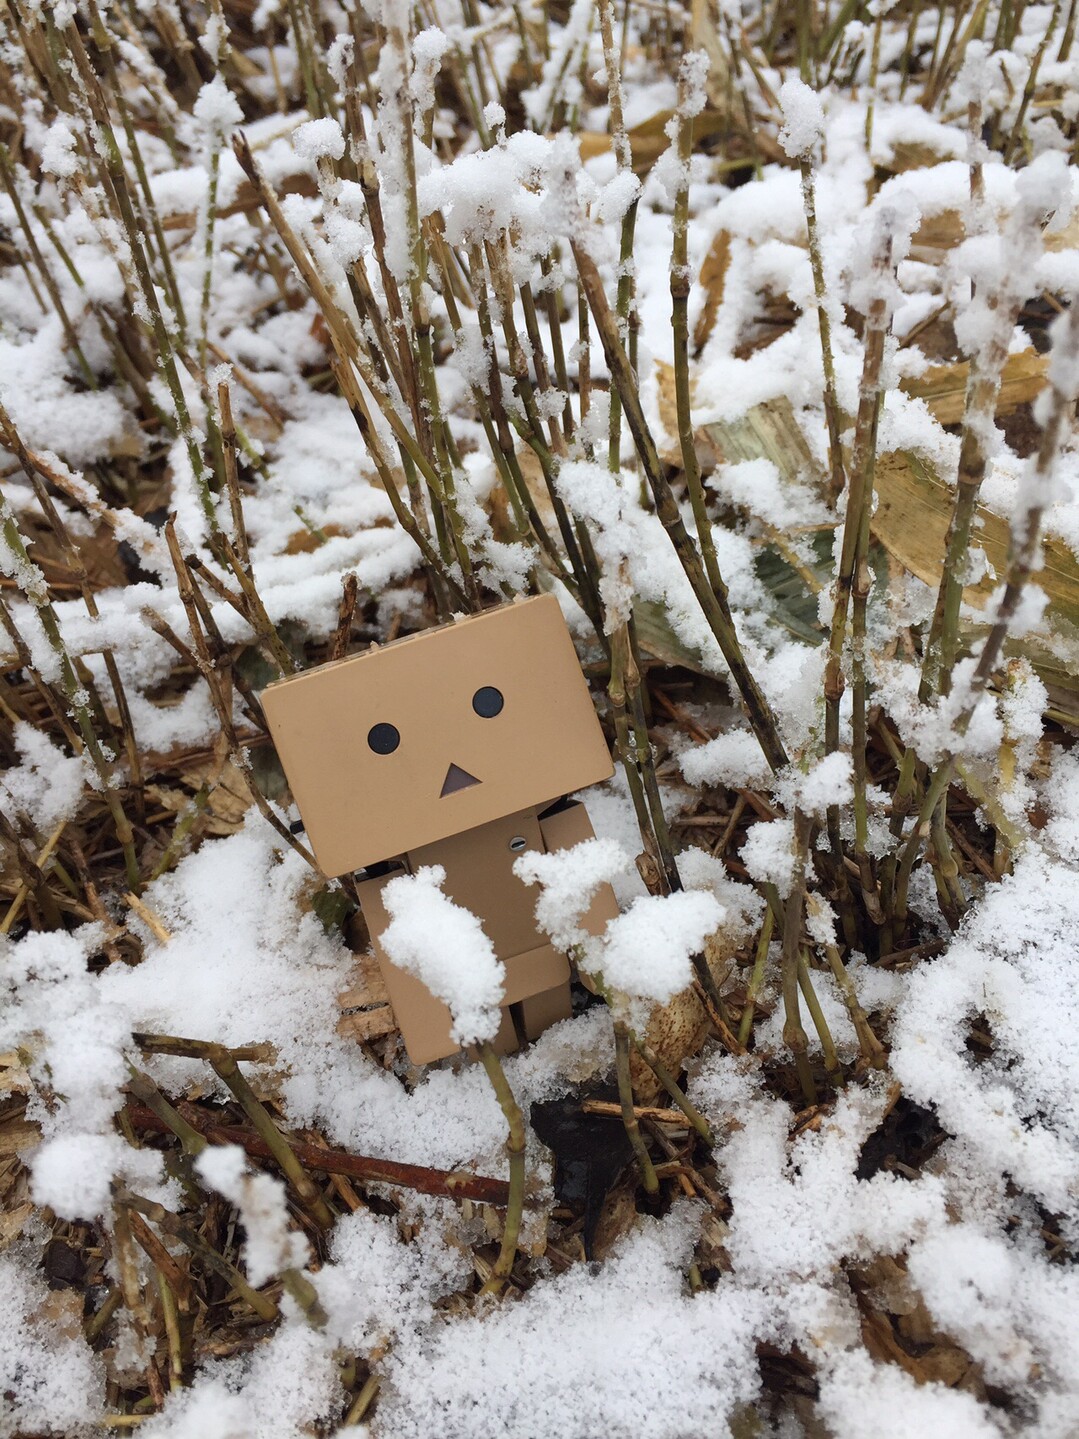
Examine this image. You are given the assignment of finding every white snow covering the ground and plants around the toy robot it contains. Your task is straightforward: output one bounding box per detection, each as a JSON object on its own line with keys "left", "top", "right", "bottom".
{"left": 0, "top": 0, "right": 1079, "bottom": 1439}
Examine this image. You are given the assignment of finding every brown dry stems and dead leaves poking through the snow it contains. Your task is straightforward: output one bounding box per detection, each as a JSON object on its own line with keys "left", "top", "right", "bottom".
{"left": 0, "top": 0, "right": 1079, "bottom": 1433}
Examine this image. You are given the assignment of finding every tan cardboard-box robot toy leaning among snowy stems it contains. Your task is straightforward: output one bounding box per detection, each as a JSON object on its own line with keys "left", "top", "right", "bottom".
{"left": 262, "top": 596, "right": 617, "bottom": 1065}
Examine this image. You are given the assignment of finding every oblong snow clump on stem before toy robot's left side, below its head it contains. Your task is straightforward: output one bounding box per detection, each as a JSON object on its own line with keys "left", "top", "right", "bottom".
{"left": 381, "top": 865, "right": 506, "bottom": 1048}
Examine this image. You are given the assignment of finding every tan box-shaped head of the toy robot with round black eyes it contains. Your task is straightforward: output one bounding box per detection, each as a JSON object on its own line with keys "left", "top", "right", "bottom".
{"left": 262, "top": 596, "right": 611, "bottom": 875}
